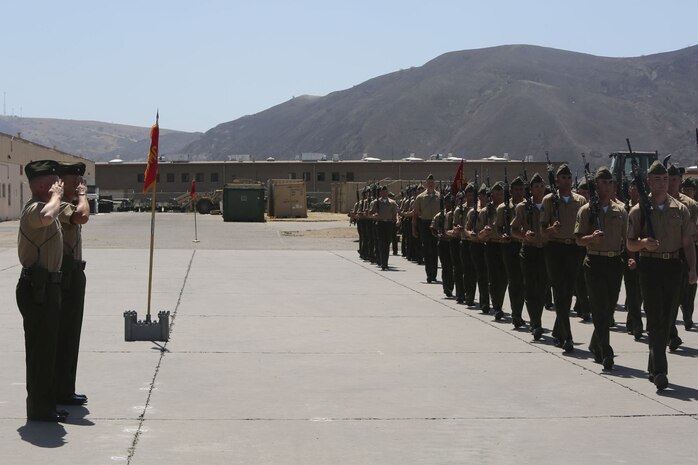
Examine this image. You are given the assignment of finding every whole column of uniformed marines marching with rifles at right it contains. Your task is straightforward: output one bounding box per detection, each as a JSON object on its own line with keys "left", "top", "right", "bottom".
{"left": 350, "top": 160, "right": 698, "bottom": 390}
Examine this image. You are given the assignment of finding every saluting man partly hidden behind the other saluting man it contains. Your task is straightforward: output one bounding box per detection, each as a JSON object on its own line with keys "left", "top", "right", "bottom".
{"left": 56, "top": 162, "right": 90, "bottom": 405}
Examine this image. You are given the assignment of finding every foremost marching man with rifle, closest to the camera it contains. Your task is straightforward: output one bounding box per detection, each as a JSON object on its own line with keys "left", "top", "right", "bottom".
{"left": 627, "top": 160, "right": 696, "bottom": 391}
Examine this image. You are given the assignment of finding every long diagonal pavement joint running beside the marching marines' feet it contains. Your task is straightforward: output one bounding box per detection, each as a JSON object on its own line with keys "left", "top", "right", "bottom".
{"left": 332, "top": 252, "right": 693, "bottom": 418}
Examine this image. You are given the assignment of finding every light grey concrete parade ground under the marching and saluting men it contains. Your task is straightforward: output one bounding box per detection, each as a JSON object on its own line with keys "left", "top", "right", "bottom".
{"left": 0, "top": 213, "right": 698, "bottom": 465}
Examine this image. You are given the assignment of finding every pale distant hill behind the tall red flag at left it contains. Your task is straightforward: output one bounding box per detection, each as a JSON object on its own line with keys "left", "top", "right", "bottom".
{"left": 0, "top": 116, "right": 201, "bottom": 161}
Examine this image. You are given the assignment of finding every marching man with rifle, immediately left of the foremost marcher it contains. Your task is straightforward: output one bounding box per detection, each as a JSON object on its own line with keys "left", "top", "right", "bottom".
{"left": 574, "top": 167, "right": 627, "bottom": 370}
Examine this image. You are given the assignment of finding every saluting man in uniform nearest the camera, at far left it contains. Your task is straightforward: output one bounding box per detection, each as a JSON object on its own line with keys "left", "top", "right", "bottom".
{"left": 16, "top": 160, "right": 65, "bottom": 422}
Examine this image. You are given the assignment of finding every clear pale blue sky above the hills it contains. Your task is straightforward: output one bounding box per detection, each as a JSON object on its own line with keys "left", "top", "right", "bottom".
{"left": 0, "top": 0, "right": 698, "bottom": 131}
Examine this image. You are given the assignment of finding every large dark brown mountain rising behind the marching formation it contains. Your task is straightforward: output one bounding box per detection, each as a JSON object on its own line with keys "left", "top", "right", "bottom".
{"left": 186, "top": 45, "right": 698, "bottom": 164}
